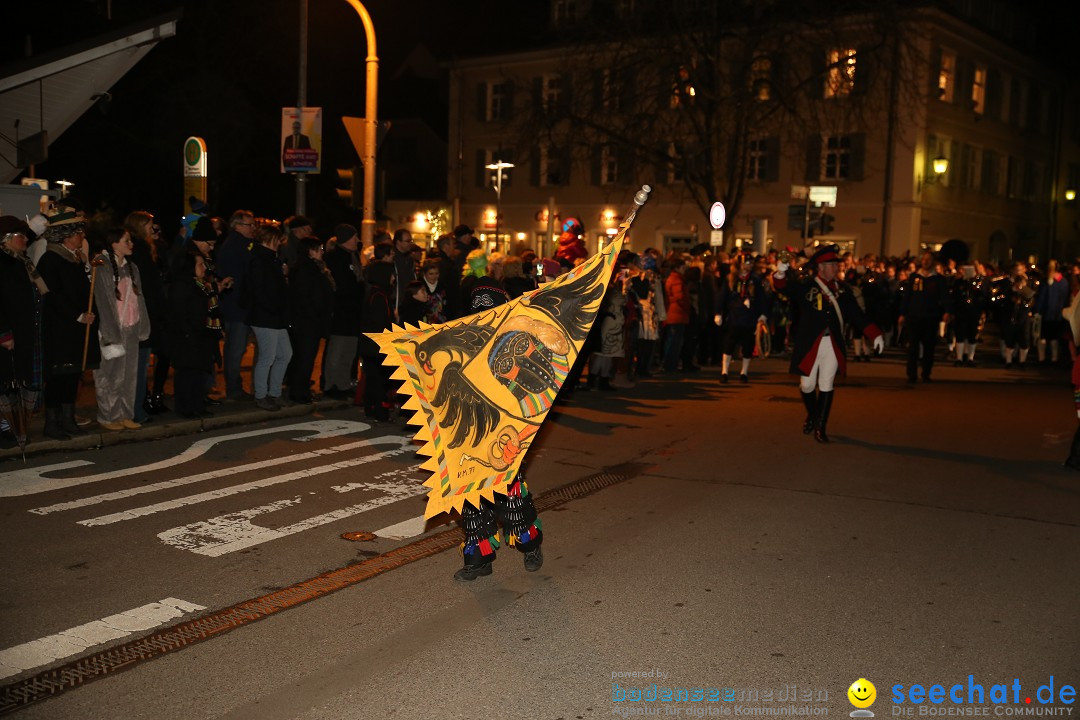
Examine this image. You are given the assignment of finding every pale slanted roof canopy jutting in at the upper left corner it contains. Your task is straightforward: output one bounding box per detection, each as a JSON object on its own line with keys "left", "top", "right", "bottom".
{"left": 0, "top": 10, "right": 181, "bottom": 182}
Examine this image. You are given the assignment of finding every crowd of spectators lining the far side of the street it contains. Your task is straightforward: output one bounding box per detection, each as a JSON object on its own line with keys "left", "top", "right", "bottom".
{"left": 0, "top": 202, "right": 1080, "bottom": 444}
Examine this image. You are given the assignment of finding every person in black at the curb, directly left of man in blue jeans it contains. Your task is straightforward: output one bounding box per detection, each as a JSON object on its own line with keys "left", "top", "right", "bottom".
{"left": 167, "top": 245, "right": 221, "bottom": 419}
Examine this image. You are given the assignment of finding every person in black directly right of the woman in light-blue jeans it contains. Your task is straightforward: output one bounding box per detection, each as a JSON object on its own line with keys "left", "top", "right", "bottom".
{"left": 287, "top": 235, "right": 334, "bottom": 405}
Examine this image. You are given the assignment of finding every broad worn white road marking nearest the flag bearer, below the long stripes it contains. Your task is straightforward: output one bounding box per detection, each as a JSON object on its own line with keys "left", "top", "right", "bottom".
{"left": 158, "top": 481, "right": 428, "bottom": 557}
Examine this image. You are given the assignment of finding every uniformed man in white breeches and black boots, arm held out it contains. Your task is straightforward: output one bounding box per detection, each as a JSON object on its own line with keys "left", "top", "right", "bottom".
{"left": 773, "top": 245, "right": 885, "bottom": 443}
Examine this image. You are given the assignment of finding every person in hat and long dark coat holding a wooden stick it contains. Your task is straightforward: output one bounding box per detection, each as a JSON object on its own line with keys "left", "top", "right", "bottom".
{"left": 38, "top": 206, "right": 100, "bottom": 440}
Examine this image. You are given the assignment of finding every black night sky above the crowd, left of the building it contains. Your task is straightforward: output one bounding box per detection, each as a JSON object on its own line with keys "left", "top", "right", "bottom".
{"left": 0, "top": 0, "right": 1078, "bottom": 234}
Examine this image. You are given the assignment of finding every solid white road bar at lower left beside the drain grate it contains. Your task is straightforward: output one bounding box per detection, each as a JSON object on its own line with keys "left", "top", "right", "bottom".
{"left": 0, "top": 598, "right": 206, "bottom": 679}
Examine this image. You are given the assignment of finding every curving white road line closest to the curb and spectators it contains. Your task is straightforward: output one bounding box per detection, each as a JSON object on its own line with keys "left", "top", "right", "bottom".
{"left": 0, "top": 420, "right": 370, "bottom": 498}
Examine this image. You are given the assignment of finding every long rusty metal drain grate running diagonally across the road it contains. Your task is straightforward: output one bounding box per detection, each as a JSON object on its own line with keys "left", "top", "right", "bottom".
{"left": 0, "top": 463, "right": 646, "bottom": 715}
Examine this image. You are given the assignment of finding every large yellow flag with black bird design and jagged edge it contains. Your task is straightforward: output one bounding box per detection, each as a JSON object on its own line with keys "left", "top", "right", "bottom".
{"left": 367, "top": 186, "right": 649, "bottom": 517}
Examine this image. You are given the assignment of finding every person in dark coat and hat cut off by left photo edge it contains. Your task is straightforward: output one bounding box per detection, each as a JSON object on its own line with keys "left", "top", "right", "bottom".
{"left": 0, "top": 215, "right": 49, "bottom": 447}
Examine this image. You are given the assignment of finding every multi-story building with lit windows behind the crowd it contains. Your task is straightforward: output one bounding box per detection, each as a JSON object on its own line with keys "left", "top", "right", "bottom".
{"left": 427, "top": 1, "right": 1080, "bottom": 262}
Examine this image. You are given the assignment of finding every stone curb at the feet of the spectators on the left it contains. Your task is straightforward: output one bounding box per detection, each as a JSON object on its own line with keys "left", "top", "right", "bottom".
{"left": 0, "top": 400, "right": 353, "bottom": 463}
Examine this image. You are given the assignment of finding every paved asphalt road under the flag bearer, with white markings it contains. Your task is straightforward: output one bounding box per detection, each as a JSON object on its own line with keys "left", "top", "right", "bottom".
{"left": 0, "top": 361, "right": 1080, "bottom": 718}
